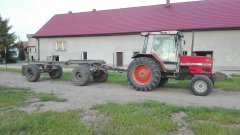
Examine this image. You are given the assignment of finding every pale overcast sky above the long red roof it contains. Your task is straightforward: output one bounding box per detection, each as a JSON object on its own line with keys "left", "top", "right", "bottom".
{"left": 0, "top": 0, "right": 199, "bottom": 41}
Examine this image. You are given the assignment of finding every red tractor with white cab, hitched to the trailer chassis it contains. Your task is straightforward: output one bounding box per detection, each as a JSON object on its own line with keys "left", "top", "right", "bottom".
{"left": 127, "top": 31, "right": 214, "bottom": 96}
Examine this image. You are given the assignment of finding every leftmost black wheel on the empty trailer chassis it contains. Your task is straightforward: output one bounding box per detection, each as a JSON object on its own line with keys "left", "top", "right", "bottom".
{"left": 25, "top": 64, "right": 41, "bottom": 82}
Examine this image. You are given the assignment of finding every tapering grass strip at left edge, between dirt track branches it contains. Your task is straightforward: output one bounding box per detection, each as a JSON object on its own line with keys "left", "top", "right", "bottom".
{"left": 0, "top": 86, "right": 66, "bottom": 109}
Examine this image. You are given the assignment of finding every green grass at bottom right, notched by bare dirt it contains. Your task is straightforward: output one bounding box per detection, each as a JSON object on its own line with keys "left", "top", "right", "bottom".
{"left": 96, "top": 101, "right": 240, "bottom": 135}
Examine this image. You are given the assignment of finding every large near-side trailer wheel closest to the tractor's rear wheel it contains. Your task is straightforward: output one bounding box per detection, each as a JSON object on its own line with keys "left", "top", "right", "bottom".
{"left": 72, "top": 66, "right": 90, "bottom": 86}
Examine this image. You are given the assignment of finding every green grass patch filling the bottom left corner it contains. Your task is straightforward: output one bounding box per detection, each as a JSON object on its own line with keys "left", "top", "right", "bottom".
{"left": 0, "top": 111, "right": 92, "bottom": 135}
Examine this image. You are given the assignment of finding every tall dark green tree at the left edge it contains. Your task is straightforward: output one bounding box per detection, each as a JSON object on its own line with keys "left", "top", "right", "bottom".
{"left": 0, "top": 15, "right": 17, "bottom": 60}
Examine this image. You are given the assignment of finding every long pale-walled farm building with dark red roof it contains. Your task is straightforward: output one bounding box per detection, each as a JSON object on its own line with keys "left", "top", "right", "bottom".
{"left": 28, "top": 0, "right": 240, "bottom": 70}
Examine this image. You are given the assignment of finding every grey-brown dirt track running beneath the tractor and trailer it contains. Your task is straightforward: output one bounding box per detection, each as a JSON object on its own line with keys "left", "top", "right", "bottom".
{"left": 0, "top": 72, "right": 240, "bottom": 111}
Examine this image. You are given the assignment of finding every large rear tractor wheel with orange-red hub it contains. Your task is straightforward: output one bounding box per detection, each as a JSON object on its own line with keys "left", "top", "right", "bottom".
{"left": 127, "top": 57, "right": 161, "bottom": 91}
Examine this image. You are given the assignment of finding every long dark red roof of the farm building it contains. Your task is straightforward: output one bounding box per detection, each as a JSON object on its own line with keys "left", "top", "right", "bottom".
{"left": 35, "top": 0, "right": 240, "bottom": 37}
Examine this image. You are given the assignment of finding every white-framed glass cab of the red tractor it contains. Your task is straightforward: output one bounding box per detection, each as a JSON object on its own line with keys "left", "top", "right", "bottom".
{"left": 142, "top": 31, "right": 183, "bottom": 73}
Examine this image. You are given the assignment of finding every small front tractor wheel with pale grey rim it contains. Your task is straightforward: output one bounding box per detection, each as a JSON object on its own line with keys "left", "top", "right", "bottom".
{"left": 190, "top": 75, "right": 213, "bottom": 96}
